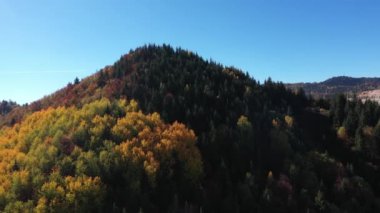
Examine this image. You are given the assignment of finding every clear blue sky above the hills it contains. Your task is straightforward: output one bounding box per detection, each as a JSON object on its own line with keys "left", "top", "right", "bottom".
{"left": 0, "top": 0, "right": 380, "bottom": 103}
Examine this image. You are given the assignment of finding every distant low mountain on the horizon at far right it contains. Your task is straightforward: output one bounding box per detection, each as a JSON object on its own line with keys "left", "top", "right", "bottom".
{"left": 286, "top": 76, "right": 380, "bottom": 98}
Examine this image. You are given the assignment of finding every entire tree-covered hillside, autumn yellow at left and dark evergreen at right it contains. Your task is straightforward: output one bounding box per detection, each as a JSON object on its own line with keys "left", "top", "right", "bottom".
{"left": 0, "top": 45, "right": 380, "bottom": 212}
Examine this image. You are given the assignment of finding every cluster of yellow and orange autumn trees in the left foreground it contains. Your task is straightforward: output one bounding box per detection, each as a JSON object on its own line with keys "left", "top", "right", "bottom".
{"left": 0, "top": 99, "right": 202, "bottom": 212}
